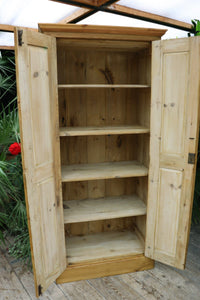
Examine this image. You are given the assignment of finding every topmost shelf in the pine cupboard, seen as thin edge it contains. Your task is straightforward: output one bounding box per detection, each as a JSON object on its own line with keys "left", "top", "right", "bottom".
{"left": 58, "top": 84, "right": 150, "bottom": 89}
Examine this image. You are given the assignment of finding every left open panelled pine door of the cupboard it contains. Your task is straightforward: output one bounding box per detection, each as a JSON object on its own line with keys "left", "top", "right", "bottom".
{"left": 15, "top": 28, "right": 66, "bottom": 296}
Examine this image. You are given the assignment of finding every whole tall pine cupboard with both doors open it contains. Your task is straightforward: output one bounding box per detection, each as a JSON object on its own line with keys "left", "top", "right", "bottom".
{"left": 15, "top": 24, "right": 200, "bottom": 296}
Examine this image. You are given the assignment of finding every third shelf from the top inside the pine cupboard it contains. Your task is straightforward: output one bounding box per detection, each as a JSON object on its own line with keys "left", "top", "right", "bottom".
{"left": 62, "top": 161, "right": 148, "bottom": 182}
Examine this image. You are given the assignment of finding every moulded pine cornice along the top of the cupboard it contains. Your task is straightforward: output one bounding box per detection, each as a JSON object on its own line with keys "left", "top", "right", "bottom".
{"left": 38, "top": 23, "right": 166, "bottom": 40}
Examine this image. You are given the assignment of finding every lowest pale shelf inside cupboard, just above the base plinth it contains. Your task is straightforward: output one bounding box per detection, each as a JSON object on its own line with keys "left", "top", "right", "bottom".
{"left": 66, "top": 231, "right": 144, "bottom": 264}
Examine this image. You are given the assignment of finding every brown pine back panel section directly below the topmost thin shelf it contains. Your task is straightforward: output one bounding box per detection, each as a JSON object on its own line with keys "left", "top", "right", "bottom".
{"left": 59, "top": 88, "right": 150, "bottom": 127}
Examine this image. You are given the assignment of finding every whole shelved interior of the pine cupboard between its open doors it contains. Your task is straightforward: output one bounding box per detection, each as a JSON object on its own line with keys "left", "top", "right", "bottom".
{"left": 57, "top": 39, "right": 151, "bottom": 264}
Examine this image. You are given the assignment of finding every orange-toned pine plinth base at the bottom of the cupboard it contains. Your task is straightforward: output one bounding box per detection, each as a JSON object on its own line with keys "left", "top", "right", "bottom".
{"left": 56, "top": 254, "right": 154, "bottom": 284}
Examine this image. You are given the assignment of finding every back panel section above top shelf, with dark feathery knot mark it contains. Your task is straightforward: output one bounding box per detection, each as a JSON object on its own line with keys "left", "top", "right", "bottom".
{"left": 57, "top": 44, "right": 151, "bottom": 84}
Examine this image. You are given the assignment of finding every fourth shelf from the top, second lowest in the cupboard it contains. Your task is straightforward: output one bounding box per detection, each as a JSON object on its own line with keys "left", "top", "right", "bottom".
{"left": 63, "top": 195, "right": 146, "bottom": 224}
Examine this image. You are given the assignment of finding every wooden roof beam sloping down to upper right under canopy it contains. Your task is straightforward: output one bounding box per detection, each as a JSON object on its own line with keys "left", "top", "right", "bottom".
{"left": 103, "top": 4, "right": 192, "bottom": 31}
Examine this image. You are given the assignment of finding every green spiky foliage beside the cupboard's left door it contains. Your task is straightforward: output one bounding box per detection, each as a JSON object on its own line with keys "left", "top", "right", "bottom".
{"left": 0, "top": 51, "right": 30, "bottom": 263}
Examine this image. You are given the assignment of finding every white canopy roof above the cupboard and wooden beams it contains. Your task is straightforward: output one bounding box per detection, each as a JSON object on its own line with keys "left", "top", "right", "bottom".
{"left": 0, "top": 0, "right": 200, "bottom": 45}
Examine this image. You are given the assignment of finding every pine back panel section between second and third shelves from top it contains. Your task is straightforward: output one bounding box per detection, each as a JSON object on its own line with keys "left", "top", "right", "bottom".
{"left": 61, "top": 135, "right": 138, "bottom": 165}
